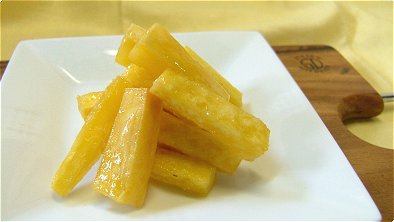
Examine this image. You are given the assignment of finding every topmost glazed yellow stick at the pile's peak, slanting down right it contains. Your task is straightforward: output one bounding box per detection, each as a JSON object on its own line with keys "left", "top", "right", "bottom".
{"left": 129, "top": 24, "right": 229, "bottom": 100}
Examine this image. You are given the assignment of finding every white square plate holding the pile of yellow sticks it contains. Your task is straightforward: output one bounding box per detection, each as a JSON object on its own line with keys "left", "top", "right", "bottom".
{"left": 1, "top": 32, "right": 380, "bottom": 220}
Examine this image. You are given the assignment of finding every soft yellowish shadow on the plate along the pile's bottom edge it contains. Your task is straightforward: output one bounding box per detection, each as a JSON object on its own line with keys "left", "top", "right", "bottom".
{"left": 49, "top": 153, "right": 286, "bottom": 214}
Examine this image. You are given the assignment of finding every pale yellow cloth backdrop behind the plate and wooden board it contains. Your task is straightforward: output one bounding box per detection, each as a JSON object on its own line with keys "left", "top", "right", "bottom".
{"left": 1, "top": 1, "right": 393, "bottom": 148}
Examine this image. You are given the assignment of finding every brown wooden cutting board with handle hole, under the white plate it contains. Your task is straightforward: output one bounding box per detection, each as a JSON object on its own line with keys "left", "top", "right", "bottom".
{"left": 0, "top": 46, "right": 394, "bottom": 221}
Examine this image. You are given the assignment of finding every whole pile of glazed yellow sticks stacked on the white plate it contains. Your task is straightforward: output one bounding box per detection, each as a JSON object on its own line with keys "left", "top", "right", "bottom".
{"left": 52, "top": 24, "right": 270, "bottom": 208}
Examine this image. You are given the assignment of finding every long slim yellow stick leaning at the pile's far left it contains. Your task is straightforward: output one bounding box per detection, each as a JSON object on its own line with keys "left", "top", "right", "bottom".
{"left": 52, "top": 73, "right": 129, "bottom": 196}
